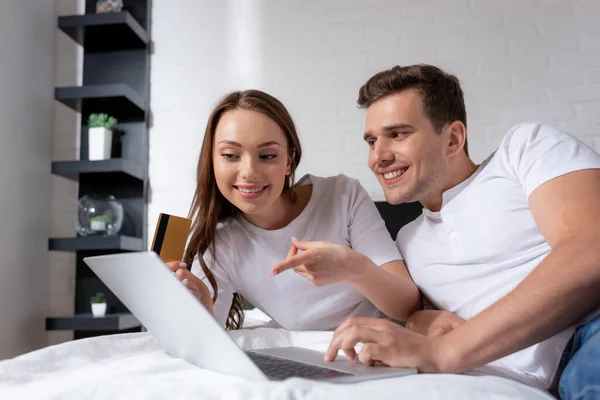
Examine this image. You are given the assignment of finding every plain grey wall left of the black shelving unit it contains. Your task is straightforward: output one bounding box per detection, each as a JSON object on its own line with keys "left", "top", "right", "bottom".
{"left": 0, "top": 0, "right": 55, "bottom": 359}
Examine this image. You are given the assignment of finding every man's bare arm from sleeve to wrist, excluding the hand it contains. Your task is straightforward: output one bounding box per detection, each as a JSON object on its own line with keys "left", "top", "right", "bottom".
{"left": 435, "top": 169, "right": 600, "bottom": 372}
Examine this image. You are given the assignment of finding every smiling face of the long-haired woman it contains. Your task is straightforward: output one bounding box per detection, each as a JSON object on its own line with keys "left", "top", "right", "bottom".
{"left": 213, "top": 109, "right": 291, "bottom": 215}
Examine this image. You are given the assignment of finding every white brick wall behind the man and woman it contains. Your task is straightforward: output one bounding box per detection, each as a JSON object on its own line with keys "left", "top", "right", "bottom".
{"left": 149, "top": 0, "right": 600, "bottom": 235}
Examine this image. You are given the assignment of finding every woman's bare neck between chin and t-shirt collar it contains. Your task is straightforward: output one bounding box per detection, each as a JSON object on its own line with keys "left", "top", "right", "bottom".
{"left": 242, "top": 185, "right": 312, "bottom": 231}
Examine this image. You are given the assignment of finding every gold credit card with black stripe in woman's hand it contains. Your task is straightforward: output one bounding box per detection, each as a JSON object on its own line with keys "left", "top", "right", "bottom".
{"left": 152, "top": 213, "right": 192, "bottom": 262}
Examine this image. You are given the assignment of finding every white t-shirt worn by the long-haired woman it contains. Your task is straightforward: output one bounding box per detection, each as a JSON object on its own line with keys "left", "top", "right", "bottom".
{"left": 192, "top": 175, "right": 401, "bottom": 330}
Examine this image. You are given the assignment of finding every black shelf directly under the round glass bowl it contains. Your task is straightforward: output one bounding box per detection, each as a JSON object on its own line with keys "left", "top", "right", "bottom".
{"left": 48, "top": 235, "right": 144, "bottom": 251}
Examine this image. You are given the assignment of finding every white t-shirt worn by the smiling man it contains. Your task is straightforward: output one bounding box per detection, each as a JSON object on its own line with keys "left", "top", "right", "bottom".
{"left": 396, "top": 123, "right": 600, "bottom": 388}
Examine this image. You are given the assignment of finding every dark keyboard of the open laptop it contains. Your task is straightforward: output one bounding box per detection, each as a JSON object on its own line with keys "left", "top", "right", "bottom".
{"left": 246, "top": 351, "right": 351, "bottom": 380}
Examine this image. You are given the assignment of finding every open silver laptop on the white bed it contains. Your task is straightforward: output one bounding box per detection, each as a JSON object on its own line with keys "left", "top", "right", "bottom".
{"left": 83, "top": 252, "right": 417, "bottom": 382}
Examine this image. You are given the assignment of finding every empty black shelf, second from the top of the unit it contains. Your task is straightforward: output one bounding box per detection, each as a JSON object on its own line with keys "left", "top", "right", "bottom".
{"left": 54, "top": 83, "right": 146, "bottom": 122}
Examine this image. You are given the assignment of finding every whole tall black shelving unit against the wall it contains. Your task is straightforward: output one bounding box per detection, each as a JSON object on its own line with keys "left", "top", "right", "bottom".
{"left": 46, "top": 0, "right": 152, "bottom": 339}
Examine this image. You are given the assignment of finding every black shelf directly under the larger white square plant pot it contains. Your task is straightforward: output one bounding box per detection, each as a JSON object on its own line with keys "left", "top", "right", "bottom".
{"left": 52, "top": 158, "right": 145, "bottom": 181}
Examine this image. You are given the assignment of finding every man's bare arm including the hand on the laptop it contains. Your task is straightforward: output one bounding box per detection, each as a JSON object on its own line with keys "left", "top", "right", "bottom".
{"left": 326, "top": 170, "right": 600, "bottom": 373}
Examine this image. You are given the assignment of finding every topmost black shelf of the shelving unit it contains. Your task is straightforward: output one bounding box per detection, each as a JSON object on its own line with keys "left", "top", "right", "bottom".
{"left": 58, "top": 12, "right": 150, "bottom": 52}
